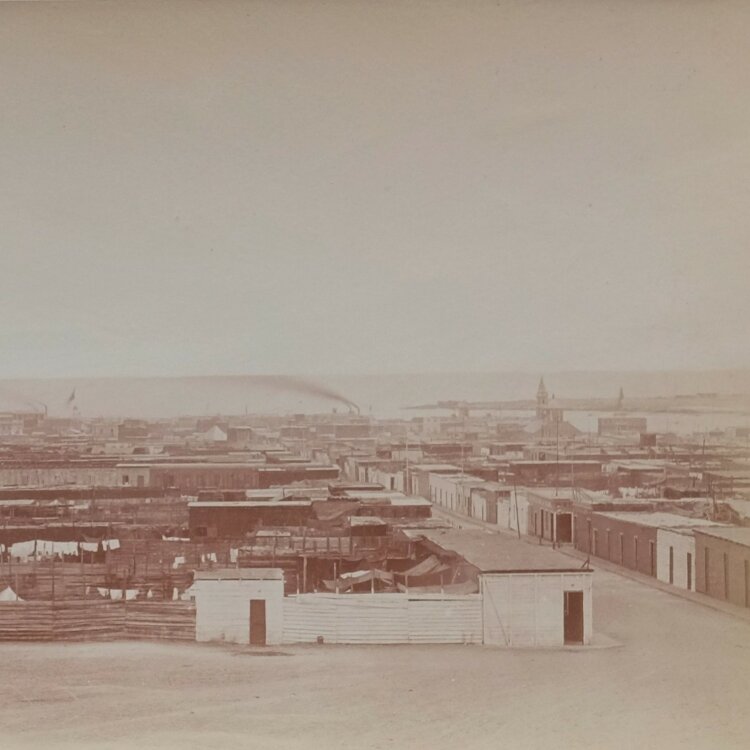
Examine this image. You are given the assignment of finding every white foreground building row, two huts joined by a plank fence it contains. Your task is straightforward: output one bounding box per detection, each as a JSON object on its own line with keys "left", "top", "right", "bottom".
{"left": 191, "top": 529, "right": 592, "bottom": 648}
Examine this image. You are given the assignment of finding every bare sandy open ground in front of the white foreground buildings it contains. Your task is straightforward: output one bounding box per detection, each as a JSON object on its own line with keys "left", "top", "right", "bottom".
{"left": 0, "top": 571, "right": 750, "bottom": 750}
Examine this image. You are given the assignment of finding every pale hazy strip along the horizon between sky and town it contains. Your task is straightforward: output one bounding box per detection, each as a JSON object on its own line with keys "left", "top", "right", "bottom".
{"left": 0, "top": 369, "right": 750, "bottom": 424}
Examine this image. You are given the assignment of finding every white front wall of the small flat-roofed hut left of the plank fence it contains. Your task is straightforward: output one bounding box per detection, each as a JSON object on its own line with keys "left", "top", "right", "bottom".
{"left": 192, "top": 580, "right": 284, "bottom": 646}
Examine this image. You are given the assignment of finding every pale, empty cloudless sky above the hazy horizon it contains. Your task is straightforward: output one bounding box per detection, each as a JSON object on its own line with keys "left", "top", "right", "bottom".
{"left": 0, "top": 0, "right": 750, "bottom": 378}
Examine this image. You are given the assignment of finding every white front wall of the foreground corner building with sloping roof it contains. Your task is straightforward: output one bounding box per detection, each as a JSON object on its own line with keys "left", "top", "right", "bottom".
{"left": 481, "top": 573, "right": 592, "bottom": 648}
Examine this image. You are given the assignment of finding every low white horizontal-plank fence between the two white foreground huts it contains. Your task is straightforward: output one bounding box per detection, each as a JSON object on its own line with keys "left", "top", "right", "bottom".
{"left": 283, "top": 594, "right": 482, "bottom": 643}
